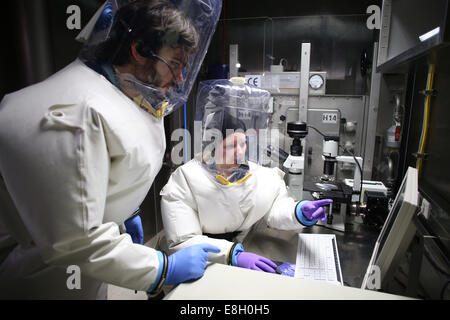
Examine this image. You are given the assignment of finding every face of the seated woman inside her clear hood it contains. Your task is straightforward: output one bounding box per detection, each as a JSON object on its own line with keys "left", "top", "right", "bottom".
{"left": 214, "top": 132, "right": 247, "bottom": 169}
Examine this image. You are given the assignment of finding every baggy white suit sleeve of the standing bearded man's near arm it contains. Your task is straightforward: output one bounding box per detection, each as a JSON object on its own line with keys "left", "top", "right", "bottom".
{"left": 0, "top": 97, "right": 159, "bottom": 291}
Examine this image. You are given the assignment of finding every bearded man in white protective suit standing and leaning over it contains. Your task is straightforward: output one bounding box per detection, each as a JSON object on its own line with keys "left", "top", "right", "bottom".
{"left": 0, "top": 0, "right": 221, "bottom": 299}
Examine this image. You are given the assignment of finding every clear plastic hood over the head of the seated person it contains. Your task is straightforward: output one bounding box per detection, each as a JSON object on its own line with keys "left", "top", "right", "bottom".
{"left": 196, "top": 80, "right": 270, "bottom": 184}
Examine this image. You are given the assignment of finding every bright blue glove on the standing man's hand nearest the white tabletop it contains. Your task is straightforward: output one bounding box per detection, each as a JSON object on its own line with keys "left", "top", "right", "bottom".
{"left": 165, "top": 244, "right": 220, "bottom": 286}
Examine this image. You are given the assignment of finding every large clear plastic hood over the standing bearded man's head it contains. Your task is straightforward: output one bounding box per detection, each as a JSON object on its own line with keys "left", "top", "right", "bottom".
{"left": 77, "top": 0, "right": 222, "bottom": 119}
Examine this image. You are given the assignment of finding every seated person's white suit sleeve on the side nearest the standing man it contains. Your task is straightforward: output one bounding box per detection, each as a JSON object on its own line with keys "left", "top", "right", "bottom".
{"left": 160, "top": 167, "right": 234, "bottom": 264}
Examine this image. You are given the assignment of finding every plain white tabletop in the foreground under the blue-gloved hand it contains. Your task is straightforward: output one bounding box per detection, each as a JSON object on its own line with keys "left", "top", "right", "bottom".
{"left": 164, "top": 263, "right": 410, "bottom": 300}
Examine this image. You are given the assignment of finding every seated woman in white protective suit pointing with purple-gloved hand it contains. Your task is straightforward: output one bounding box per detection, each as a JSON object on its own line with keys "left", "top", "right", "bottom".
{"left": 161, "top": 80, "right": 332, "bottom": 273}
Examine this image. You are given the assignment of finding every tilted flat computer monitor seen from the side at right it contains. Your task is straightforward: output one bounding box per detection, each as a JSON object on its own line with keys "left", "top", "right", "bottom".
{"left": 361, "top": 167, "right": 419, "bottom": 289}
